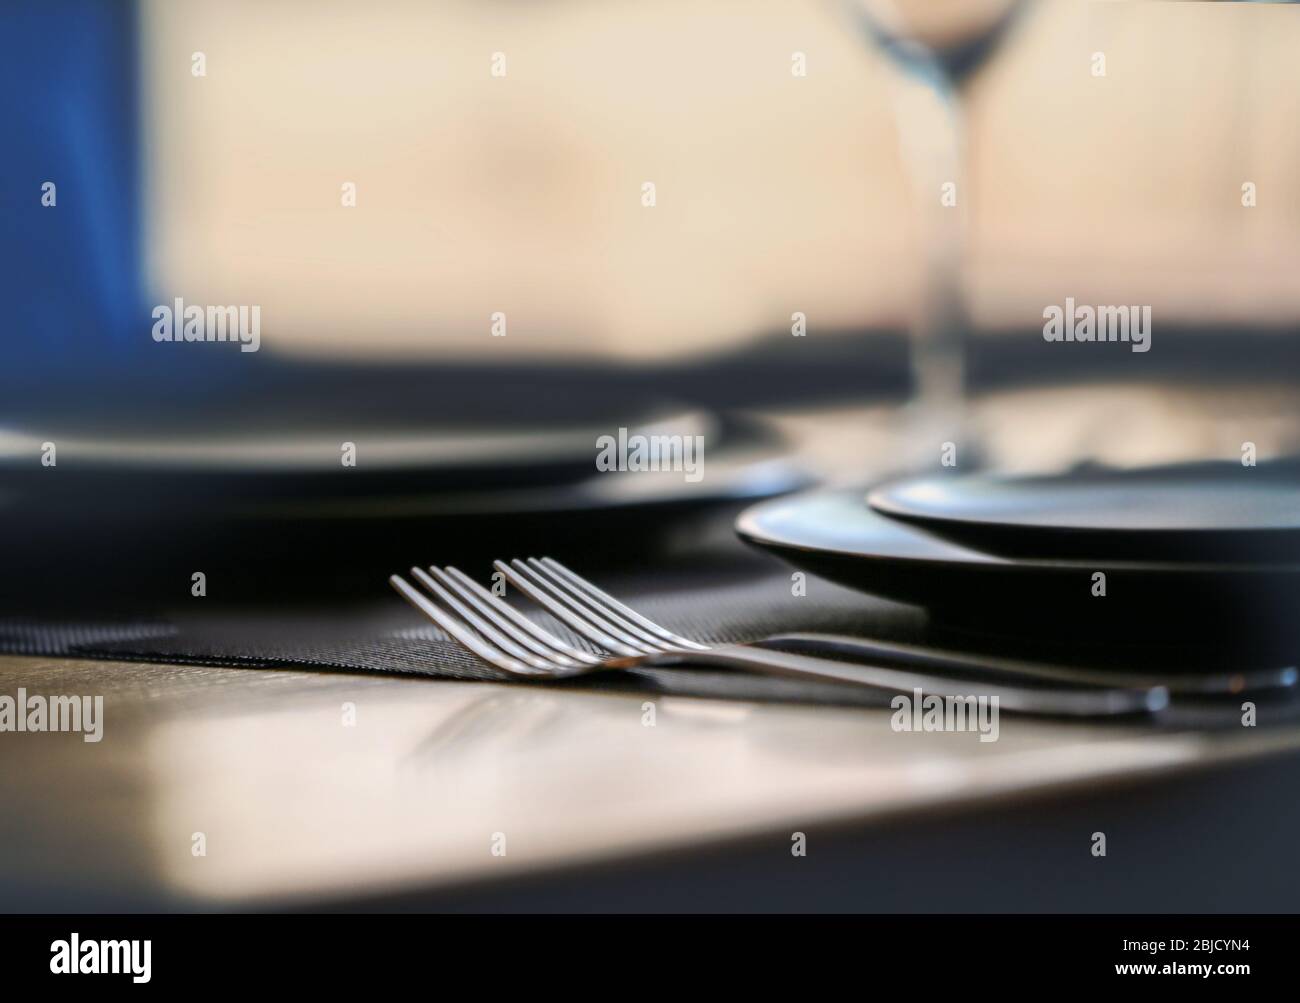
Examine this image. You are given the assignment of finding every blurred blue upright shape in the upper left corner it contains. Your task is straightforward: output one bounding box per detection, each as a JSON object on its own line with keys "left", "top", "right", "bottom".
{"left": 0, "top": 0, "right": 148, "bottom": 399}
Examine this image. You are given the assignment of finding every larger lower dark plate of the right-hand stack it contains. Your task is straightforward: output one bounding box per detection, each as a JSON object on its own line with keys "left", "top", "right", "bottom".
{"left": 736, "top": 490, "right": 1300, "bottom": 647}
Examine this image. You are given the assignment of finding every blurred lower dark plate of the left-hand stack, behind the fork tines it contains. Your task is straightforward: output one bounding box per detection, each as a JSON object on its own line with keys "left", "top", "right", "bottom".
{"left": 0, "top": 418, "right": 811, "bottom": 602}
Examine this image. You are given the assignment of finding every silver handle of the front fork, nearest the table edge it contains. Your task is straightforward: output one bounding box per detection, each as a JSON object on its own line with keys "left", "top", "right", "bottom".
{"left": 634, "top": 644, "right": 1167, "bottom": 717}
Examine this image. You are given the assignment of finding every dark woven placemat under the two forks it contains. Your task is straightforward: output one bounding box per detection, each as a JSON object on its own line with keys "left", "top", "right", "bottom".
{"left": 0, "top": 555, "right": 1300, "bottom": 728}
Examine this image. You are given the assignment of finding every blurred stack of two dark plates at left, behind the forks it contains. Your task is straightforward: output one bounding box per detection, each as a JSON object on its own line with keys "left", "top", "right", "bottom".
{"left": 0, "top": 394, "right": 810, "bottom": 609}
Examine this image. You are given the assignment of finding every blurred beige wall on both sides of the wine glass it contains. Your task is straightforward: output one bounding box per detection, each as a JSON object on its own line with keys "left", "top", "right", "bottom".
{"left": 144, "top": 0, "right": 1300, "bottom": 359}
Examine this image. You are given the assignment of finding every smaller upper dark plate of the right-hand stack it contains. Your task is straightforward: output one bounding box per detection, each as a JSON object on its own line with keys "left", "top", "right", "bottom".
{"left": 867, "top": 463, "right": 1300, "bottom": 561}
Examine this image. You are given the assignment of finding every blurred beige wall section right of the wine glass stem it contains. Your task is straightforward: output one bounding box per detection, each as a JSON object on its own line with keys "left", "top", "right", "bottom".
{"left": 967, "top": 1, "right": 1300, "bottom": 326}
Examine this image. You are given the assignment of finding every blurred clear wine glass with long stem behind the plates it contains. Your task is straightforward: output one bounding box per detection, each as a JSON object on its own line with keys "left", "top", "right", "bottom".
{"left": 846, "top": 0, "right": 1027, "bottom": 468}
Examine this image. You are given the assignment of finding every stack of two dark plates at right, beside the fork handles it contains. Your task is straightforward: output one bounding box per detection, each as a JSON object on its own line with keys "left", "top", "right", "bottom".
{"left": 737, "top": 461, "right": 1300, "bottom": 648}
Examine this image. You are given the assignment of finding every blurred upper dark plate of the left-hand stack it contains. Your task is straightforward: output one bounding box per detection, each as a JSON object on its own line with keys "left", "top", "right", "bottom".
{"left": 0, "top": 408, "right": 725, "bottom": 521}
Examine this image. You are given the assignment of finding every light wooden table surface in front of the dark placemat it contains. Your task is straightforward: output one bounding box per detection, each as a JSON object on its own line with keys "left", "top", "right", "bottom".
{"left": 0, "top": 656, "right": 1300, "bottom": 911}
